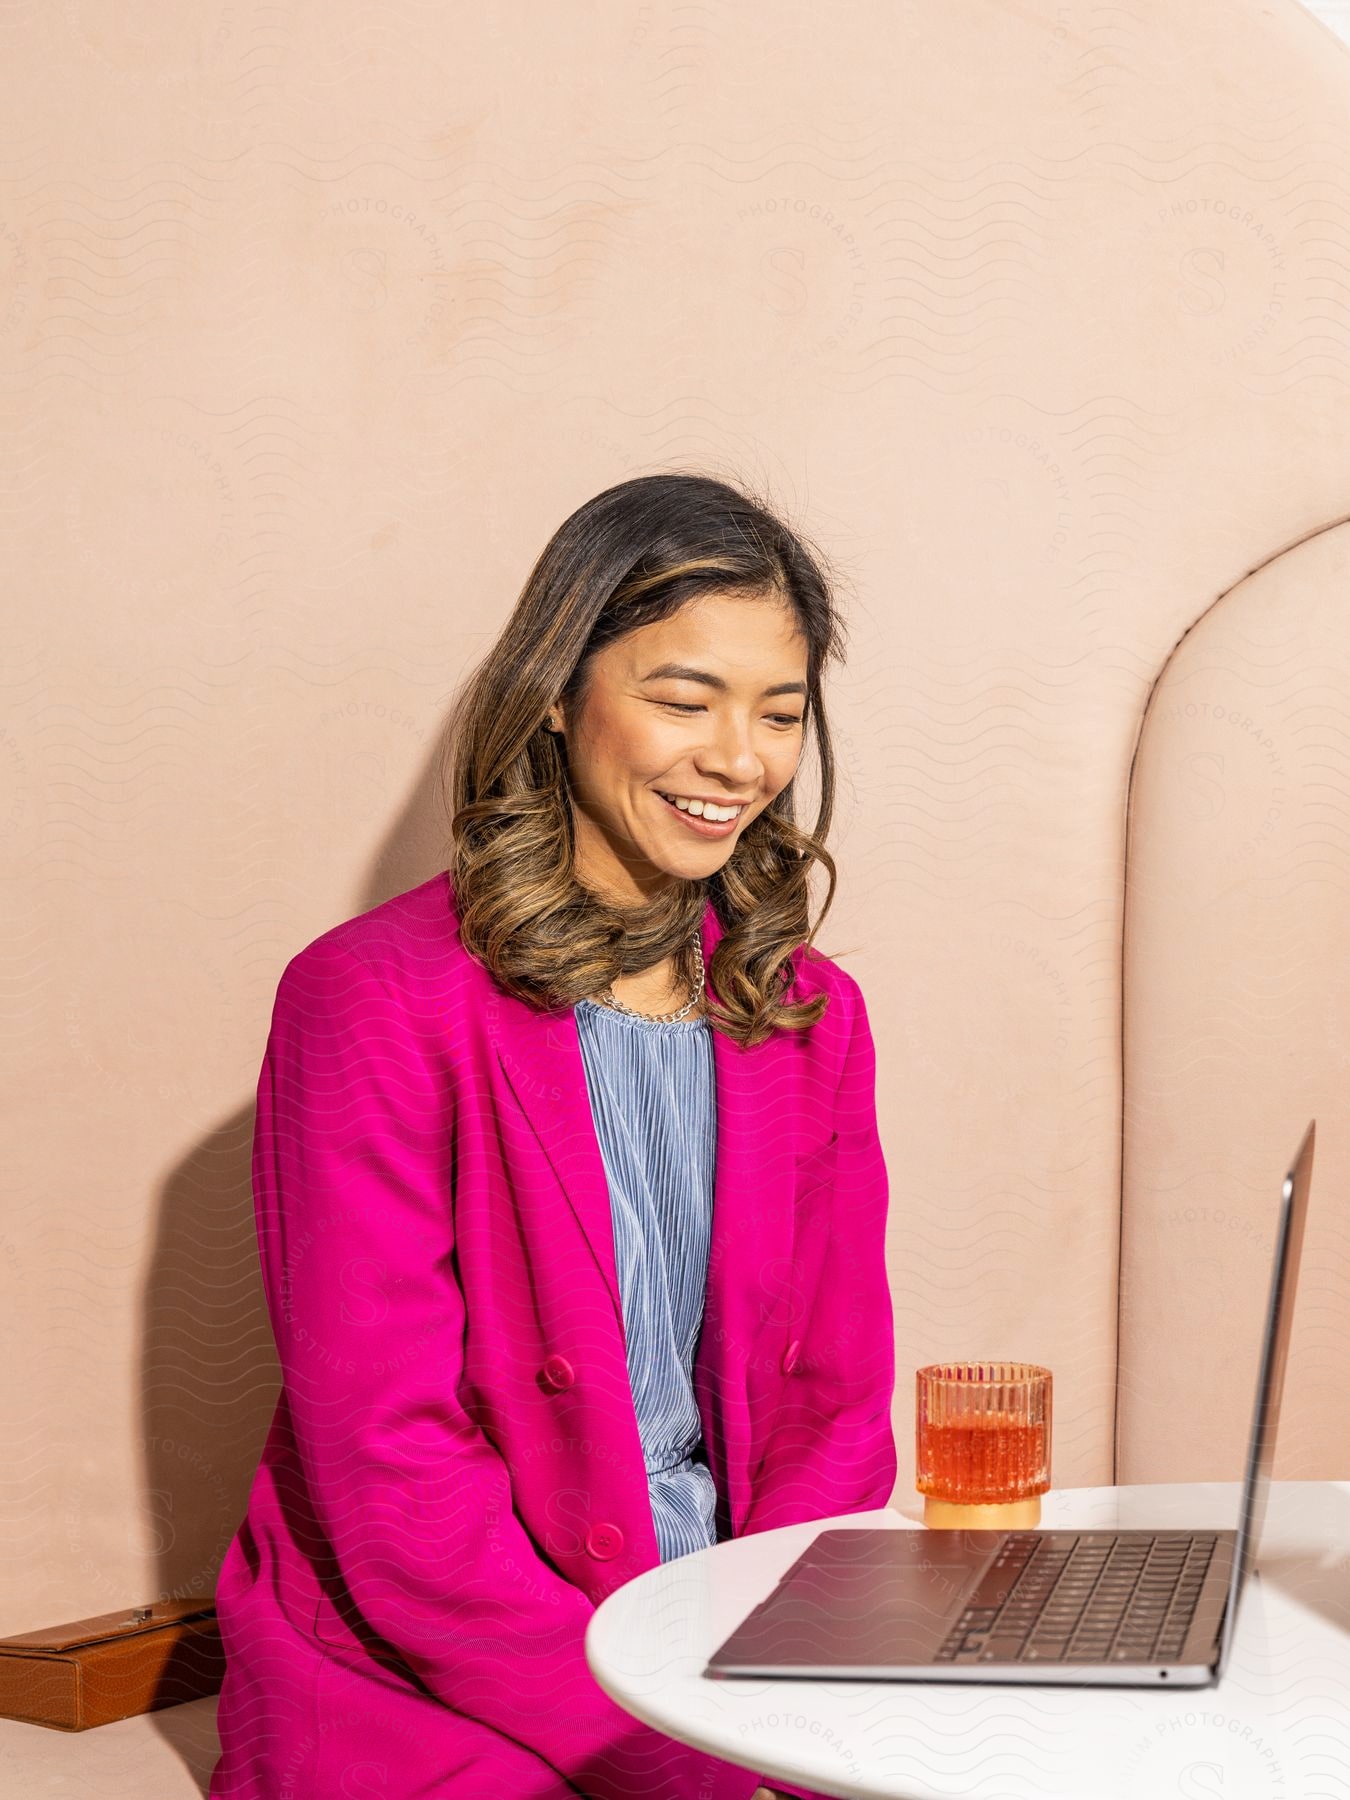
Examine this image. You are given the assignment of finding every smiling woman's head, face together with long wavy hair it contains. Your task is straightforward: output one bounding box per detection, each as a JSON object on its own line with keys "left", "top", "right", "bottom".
{"left": 446, "top": 473, "right": 844, "bottom": 1044}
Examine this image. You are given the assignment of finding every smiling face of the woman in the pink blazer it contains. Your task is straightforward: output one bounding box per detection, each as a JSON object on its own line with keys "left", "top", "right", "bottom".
{"left": 549, "top": 596, "right": 806, "bottom": 905}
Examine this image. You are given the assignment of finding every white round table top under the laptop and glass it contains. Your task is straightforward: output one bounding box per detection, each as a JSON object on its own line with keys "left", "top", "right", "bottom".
{"left": 585, "top": 1481, "right": 1350, "bottom": 1800}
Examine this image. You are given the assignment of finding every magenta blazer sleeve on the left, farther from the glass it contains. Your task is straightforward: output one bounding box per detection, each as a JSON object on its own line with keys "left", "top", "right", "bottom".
{"left": 252, "top": 938, "right": 756, "bottom": 1800}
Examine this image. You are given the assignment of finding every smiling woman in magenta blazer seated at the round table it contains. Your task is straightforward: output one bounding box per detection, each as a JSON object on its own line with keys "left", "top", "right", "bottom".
{"left": 211, "top": 473, "right": 896, "bottom": 1800}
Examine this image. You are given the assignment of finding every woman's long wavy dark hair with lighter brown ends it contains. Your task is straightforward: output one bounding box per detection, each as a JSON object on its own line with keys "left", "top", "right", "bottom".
{"left": 443, "top": 473, "right": 844, "bottom": 1044}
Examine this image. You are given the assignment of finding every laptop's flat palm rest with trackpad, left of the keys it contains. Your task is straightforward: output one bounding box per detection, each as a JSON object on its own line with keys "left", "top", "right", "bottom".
{"left": 715, "top": 1528, "right": 1001, "bottom": 1670}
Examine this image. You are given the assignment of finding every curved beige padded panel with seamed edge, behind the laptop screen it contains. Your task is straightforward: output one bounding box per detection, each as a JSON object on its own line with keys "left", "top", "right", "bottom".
{"left": 1120, "top": 526, "right": 1350, "bottom": 1481}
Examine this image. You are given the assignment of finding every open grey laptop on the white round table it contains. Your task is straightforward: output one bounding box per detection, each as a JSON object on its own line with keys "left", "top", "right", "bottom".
{"left": 704, "top": 1120, "right": 1318, "bottom": 1687}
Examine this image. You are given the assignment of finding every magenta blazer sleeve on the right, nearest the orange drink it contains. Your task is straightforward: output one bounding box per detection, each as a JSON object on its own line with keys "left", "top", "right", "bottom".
{"left": 742, "top": 976, "right": 896, "bottom": 1535}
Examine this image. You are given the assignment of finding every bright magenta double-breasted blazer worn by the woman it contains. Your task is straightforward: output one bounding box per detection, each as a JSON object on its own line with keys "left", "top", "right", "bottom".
{"left": 209, "top": 873, "right": 896, "bottom": 1800}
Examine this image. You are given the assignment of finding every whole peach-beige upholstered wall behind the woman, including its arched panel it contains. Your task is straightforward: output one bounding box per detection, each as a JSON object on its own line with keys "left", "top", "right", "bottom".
{"left": 0, "top": 0, "right": 1350, "bottom": 1631}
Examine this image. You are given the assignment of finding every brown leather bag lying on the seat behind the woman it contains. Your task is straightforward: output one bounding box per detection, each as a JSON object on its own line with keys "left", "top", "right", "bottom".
{"left": 0, "top": 1595, "right": 225, "bottom": 1732}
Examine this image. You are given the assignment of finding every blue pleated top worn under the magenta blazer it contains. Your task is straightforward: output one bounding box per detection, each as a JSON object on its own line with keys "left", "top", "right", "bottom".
{"left": 576, "top": 1001, "right": 716, "bottom": 1562}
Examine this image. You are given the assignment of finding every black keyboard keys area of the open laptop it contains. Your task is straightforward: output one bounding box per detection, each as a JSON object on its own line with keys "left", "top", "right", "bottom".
{"left": 934, "top": 1532, "right": 1217, "bottom": 1663}
